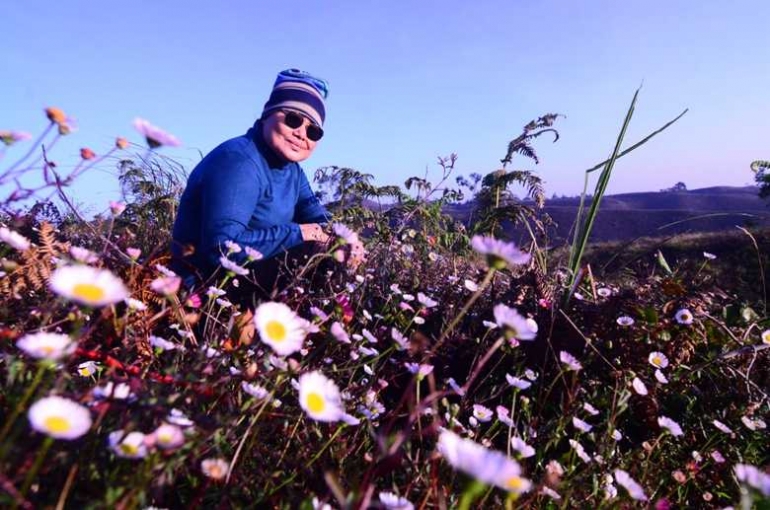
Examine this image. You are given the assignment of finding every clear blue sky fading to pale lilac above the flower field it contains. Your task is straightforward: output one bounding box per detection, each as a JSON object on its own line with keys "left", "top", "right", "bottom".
{"left": 0, "top": 0, "right": 770, "bottom": 210}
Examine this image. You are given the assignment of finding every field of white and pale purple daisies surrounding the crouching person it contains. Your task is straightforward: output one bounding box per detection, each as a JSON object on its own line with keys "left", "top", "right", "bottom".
{"left": 0, "top": 108, "right": 770, "bottom": 510}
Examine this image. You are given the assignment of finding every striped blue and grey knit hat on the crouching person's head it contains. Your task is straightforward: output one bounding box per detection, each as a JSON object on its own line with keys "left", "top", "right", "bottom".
{"left": 262, "top": 69, "right": 329, "bottom": 126}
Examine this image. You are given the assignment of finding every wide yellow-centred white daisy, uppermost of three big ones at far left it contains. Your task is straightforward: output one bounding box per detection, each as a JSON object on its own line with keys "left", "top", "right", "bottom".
{"left": 50, "top": 266, "right": 129, "bottom": 307}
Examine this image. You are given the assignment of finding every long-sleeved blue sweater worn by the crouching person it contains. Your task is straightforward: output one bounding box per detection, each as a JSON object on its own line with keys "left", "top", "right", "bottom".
{"left": 171, "top": 121, "right": 330, "bottom": 282}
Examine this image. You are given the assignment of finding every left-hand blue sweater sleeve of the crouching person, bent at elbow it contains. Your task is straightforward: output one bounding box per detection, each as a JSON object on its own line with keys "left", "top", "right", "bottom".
{"left": 200, "top": 151, "right": 302, "bottom": 267}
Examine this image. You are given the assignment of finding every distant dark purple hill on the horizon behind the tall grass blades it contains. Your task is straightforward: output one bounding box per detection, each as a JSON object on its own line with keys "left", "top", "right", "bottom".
{"left": 447, "top": 186, "right": 770, "bottom": 243}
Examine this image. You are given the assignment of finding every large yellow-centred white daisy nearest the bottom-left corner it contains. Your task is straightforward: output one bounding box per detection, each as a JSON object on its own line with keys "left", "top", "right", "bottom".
{"left": 27, "top": 397, "right": 91, "bottom": 440}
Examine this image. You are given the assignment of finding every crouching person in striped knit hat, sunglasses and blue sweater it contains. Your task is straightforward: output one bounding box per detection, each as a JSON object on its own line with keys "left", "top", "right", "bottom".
{"left": 172, "top": 69, "right": 363, "bottom": 298}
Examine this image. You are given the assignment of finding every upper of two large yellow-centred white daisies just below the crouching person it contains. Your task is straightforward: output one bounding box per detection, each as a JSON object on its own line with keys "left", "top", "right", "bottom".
{"left": 254, "top": 301, "right": 305, "bottom": 356}
